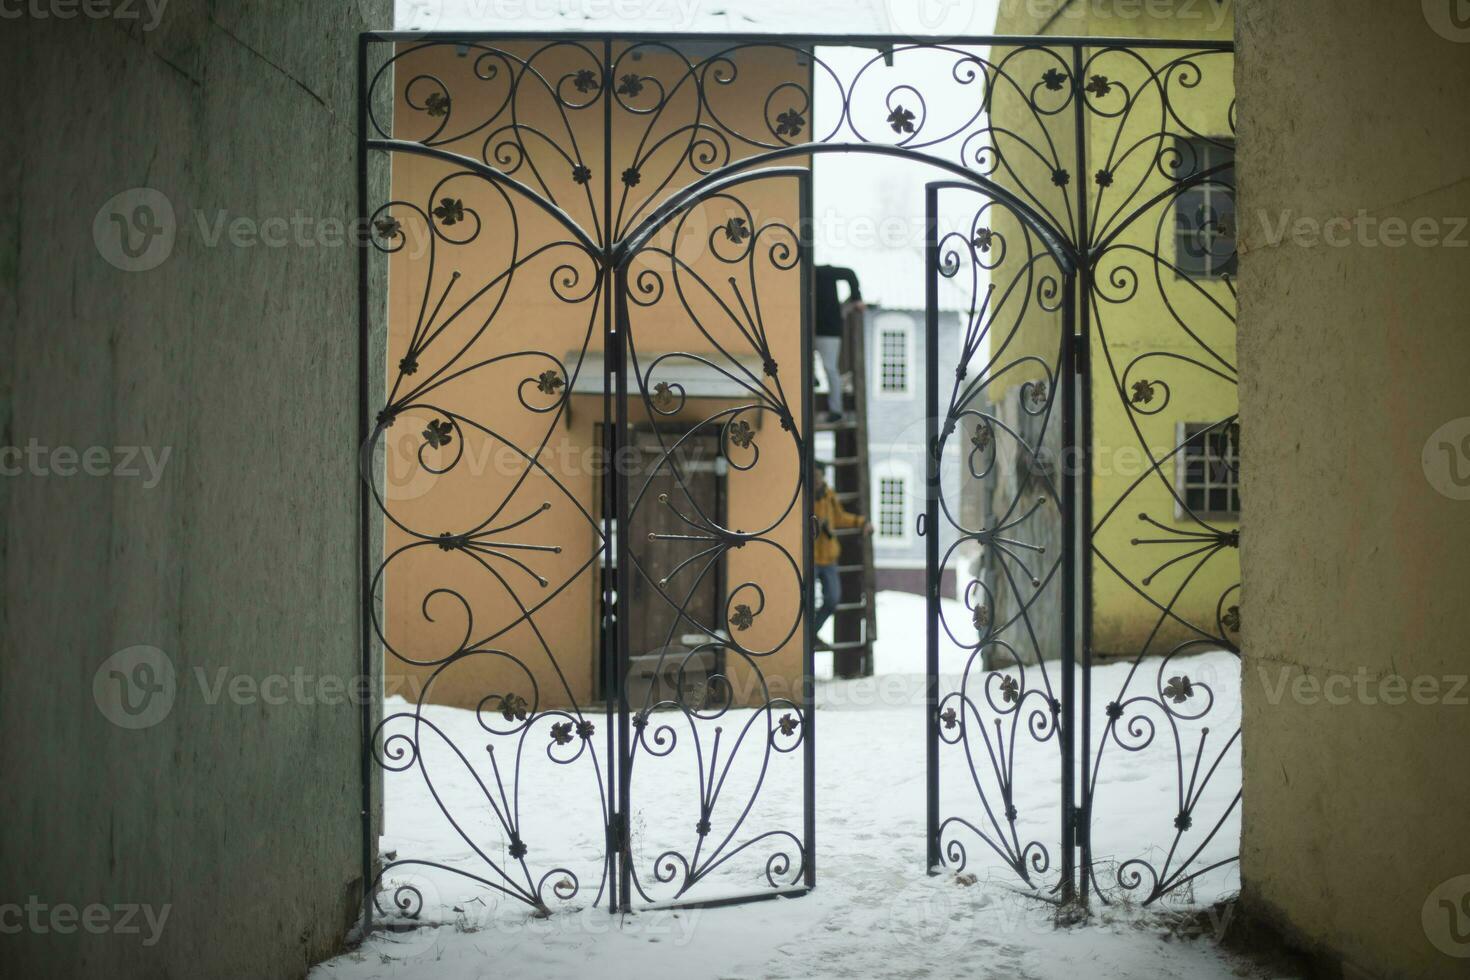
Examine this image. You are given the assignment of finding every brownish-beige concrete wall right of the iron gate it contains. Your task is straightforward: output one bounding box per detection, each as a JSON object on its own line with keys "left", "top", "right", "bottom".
{"left": 1236, "top": 0, "right": 1470, "bottom": 977}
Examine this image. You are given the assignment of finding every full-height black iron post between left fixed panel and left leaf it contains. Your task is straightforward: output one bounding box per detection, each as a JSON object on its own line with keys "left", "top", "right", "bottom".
{"left": 598, "top": 40, "right": 622, "bottom": 915}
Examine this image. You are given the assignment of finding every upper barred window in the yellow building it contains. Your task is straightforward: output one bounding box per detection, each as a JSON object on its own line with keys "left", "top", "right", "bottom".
{"left": 1175, "top": 140, "right": 1236, "bottom": 279}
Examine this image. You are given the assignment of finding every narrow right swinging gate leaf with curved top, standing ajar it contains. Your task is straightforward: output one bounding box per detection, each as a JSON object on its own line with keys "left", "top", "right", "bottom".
{"left": 926, "top": 184, "right": 1072, "bottom": 895}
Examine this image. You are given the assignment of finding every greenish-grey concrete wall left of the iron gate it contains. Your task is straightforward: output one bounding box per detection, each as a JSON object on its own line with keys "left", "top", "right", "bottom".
{"left": 0, "top": 0, "right": 391, "bottom": 977}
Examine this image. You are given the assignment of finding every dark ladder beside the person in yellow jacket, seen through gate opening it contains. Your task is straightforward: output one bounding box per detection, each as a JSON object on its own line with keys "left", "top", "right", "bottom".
{"left": 816, "top": 310, "right": 878, "bottom": 677}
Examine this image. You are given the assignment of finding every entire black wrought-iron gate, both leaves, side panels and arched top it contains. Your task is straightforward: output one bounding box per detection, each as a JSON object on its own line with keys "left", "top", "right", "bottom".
{"left": 360, "top": 34, "right": 1239, "bottom": 917}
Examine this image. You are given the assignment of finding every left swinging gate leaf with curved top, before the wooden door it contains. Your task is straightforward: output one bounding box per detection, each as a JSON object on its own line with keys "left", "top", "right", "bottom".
{"left": 619, "top": 169, "right": 810, "bottom": 902}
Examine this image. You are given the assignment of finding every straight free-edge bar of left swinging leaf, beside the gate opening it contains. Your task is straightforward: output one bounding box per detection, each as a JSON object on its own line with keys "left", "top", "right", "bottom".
{"left": 797, "top": 172, "right": 817, "bottom": 887}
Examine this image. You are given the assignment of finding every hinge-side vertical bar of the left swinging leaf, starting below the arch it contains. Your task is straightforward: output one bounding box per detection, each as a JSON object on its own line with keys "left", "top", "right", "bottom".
{"left": 612, "top": 264, "right": 632, "bottom": 912}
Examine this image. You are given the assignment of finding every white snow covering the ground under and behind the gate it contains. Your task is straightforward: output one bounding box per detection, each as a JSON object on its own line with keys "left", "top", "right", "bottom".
{"left": 312, "top": 592, "right": 1255, "bottom": 980}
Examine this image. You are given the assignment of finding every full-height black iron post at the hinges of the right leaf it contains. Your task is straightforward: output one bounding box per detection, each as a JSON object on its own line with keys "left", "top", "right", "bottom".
{"left": 1064, "top": 44, "right": 1092, "bottom": 904}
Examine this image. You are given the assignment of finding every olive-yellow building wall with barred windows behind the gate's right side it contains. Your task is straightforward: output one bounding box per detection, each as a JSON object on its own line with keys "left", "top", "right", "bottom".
{"left": 992, "top": 1, "right": 1250, "bottom": 655}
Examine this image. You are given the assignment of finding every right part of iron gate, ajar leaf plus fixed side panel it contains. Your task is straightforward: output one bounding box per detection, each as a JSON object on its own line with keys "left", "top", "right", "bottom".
{"left": 923, "top": 46, "right": 1241, "bottom": 905}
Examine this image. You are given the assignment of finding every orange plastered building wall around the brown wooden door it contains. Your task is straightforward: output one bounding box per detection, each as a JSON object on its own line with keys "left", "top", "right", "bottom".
{"left": 378, "top": 44, "right": 810, "bottom": 710}
